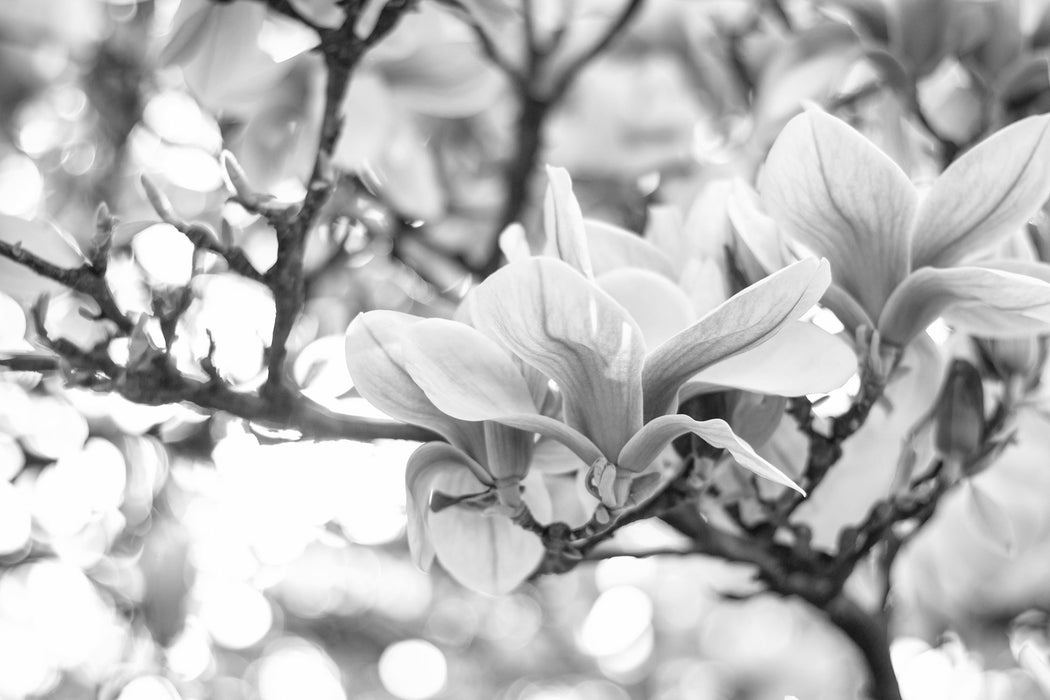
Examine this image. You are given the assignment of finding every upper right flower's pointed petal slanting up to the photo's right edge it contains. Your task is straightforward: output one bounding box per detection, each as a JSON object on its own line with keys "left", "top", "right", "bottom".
{"left": 912, "top": 114, "right": 1050, "bottom": 269}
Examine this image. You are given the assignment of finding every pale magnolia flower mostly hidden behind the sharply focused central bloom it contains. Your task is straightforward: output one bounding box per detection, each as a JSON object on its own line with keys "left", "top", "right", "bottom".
{"left": 525, "top": 167, "right": 857, "bottom": 399}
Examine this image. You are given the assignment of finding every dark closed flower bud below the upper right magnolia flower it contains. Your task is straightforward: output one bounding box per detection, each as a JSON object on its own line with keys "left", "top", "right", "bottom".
{"left": 935, "top": 359, "right": 985, "bottom": 463}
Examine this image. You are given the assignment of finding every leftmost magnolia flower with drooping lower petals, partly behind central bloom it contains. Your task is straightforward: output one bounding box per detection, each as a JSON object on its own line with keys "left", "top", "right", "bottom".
{"left": 347, "top": 311, "right": 551, "bottom": 594}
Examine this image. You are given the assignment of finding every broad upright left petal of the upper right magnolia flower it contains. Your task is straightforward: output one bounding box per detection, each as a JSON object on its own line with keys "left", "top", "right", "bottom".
{"left": 759, "top": 109, "right": 917, "bottom": 317}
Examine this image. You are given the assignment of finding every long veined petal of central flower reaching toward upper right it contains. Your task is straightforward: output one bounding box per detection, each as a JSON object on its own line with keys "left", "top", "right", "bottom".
{"left": 643, "top": 258, "right": 831, "bottom": 420}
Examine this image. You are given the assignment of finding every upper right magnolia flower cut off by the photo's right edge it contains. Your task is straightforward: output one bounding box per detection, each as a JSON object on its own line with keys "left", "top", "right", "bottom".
{"left": 755, "top": 109, "right": 1050, "bottom": 346}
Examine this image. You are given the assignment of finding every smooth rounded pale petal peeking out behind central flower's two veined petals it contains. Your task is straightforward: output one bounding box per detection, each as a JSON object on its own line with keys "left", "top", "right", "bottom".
{"left": 595, "top": 268, "right": 695, "bottom": 347}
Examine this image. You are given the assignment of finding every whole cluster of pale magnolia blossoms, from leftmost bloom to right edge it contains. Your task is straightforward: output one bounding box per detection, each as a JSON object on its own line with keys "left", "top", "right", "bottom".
{"left": 347, "top": 110, "right": 1050, "bottom": 593}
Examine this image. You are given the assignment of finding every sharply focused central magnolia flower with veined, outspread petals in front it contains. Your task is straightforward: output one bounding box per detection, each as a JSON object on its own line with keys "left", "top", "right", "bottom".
{"left": 410, "top": 250, "right": 830, "bottom": 509}
